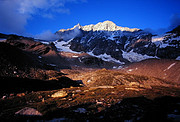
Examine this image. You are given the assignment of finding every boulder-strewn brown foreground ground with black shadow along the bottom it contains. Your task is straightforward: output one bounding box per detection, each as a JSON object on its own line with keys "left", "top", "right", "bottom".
{"left": 0, "top": 82, "right": 180, "bottom": 121}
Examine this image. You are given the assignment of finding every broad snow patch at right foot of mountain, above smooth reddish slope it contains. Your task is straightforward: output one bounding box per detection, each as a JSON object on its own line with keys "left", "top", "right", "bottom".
{"left": 122, "top": 50, "right": 156, "bottom": 62}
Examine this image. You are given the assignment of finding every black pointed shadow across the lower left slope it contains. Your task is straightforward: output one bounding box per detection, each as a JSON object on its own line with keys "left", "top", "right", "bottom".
{"left": 0, "top": 76, "right": 80, "bottom": 97}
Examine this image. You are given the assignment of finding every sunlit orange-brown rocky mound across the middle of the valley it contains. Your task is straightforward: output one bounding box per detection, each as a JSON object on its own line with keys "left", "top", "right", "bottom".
{"left": 62, "top": 67, "right": 179, "bottom": 89}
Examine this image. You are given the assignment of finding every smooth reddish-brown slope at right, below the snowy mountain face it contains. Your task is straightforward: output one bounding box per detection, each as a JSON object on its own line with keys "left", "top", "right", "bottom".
{"left": 121, "top": 59, "right": 180, "bottom": 83}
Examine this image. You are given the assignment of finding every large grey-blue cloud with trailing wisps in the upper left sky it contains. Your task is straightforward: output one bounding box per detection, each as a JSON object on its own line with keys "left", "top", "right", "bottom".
{"left": 0, "top": 0, "right": 86, "bottom": 34}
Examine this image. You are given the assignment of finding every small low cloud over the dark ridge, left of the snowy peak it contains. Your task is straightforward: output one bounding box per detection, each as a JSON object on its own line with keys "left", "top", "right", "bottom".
{"left": 34, "top": 30, "right": 60, "bottom": 41}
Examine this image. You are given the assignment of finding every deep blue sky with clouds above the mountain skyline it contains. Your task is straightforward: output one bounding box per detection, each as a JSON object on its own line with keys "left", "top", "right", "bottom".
{"left": 0, "top": 0, "right": 180, "bottom": 35}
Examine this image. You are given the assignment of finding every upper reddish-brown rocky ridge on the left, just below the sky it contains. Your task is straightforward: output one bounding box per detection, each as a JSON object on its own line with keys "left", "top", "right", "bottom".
{"left": 4, "top": 35, "right": 69, "bottom": 69}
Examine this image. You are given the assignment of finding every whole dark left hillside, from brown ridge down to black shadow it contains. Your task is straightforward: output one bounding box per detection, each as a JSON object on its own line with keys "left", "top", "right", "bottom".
{"left": 0, "top": 35, "right": 79, "bottom": 97}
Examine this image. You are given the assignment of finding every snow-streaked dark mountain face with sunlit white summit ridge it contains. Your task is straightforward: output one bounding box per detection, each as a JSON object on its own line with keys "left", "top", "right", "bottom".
{"left": 54, "top": 21, "right": 180, "bottom": 64}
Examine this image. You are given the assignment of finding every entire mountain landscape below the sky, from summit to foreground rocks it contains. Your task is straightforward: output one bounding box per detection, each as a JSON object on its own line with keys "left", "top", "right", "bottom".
{"left": 0, "top": 21, "right": 180, "bottom": 122}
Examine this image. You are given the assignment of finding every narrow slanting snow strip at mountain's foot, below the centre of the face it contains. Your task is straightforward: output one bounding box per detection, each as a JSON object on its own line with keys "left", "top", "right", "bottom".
{"left": 88, "top": 52, "right": 125, "bottom": 64}
